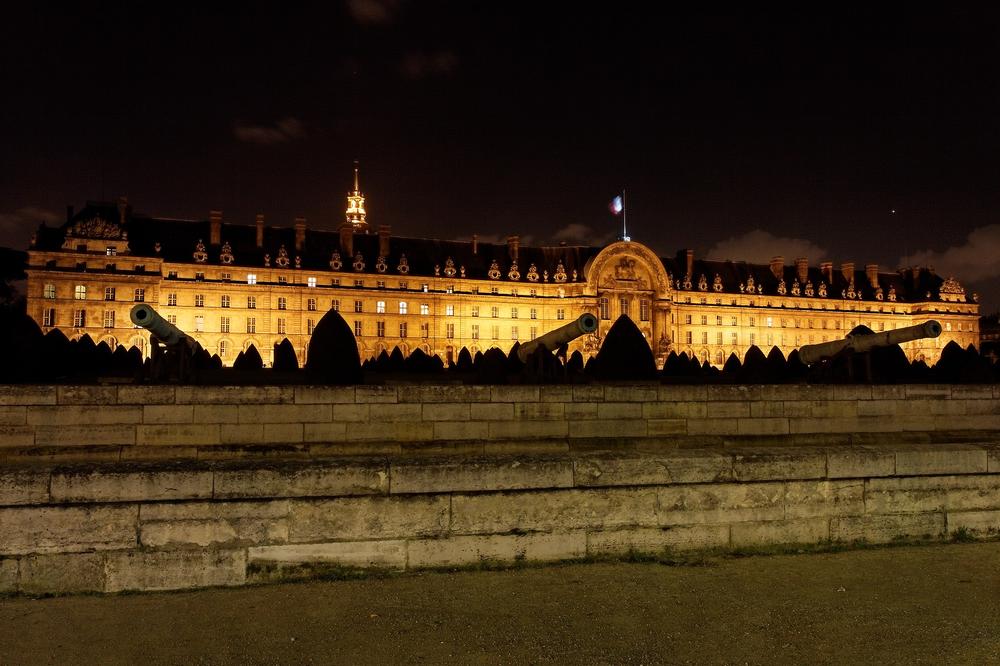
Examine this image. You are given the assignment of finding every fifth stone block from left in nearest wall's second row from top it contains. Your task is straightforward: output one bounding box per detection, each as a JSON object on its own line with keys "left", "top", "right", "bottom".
{"left": 657, "top": 483, "right": 785, "bottom": 526}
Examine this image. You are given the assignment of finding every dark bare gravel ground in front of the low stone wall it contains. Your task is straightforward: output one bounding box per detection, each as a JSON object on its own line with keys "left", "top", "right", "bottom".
{"left": 0, "top": 542, "right": 1000, "bottom": 665}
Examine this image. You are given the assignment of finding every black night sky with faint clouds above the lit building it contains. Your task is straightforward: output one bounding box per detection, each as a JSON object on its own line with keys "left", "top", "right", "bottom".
{"left": 0, "top": 0, "right": 1000, "bottom": 313}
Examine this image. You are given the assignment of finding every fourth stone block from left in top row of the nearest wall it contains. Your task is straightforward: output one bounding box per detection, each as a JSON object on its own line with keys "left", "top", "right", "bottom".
{"left": 389, "top": 458, "right": 573, "bottom": 494}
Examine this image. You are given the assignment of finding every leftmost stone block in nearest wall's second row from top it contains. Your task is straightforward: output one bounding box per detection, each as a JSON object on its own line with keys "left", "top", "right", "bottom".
{"left": 0, "top": 504, "right": 139, "bottom": 555}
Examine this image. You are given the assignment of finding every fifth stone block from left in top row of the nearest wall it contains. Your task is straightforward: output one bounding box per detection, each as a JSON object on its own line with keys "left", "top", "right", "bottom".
{"left": 574, "top": 450, "right": 733, "bottom": 487}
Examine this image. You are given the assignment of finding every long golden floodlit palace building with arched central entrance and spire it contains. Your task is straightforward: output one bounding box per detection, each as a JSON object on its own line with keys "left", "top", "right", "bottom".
{"left": 21, "top": 169, "right": 979, "bottom": 365}
